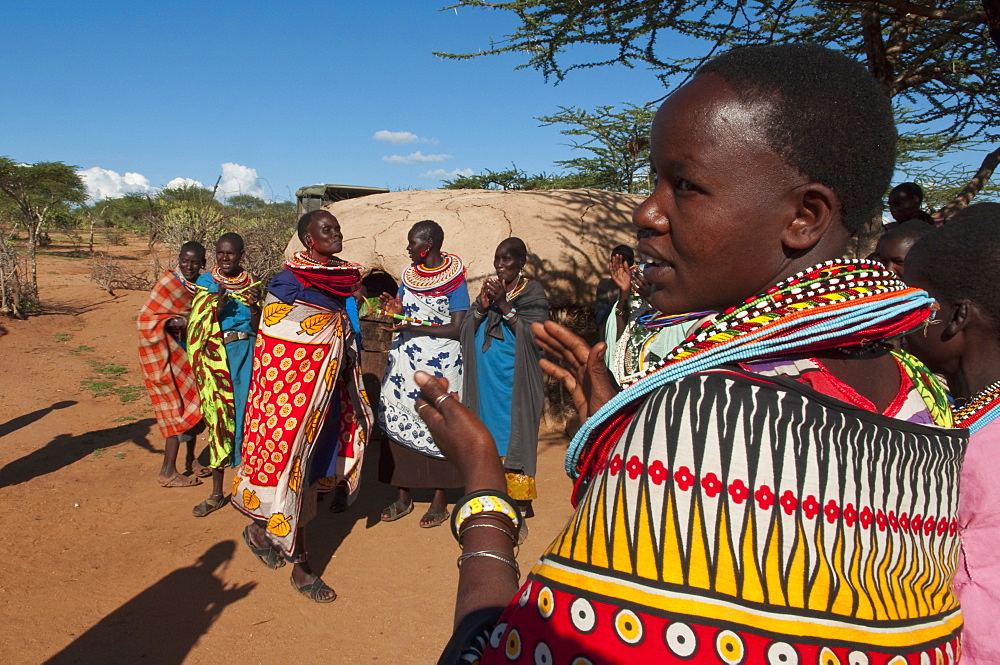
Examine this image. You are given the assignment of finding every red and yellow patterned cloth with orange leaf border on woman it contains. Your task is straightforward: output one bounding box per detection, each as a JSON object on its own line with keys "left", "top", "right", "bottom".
{"left": 232, "top": 278, "right": 371, "bottom": 557}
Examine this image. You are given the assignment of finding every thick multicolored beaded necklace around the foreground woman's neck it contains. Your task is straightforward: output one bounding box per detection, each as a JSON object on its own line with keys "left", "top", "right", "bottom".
{"left": 566, "top": 259, "right": 934, "bottom": 478}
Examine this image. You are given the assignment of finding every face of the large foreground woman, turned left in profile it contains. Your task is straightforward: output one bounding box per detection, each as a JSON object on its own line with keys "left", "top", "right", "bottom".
{"left": 632, "top": 74, "right": 806, "bottom": 314}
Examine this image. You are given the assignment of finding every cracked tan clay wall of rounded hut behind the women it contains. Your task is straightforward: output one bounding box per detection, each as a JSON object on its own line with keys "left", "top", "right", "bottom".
{"left": 285, "top": 184, "right": 642, "bottom": 308}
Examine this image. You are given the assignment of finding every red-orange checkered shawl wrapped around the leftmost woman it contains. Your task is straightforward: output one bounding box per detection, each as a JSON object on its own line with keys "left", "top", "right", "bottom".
{"left": 138, "top": 271, "right": 201, "bottom": 437}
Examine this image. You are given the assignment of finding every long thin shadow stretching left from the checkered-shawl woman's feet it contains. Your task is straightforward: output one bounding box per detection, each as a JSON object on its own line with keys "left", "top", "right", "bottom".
{"left": 0, "top": 418, "right": 159, "bottom": 488}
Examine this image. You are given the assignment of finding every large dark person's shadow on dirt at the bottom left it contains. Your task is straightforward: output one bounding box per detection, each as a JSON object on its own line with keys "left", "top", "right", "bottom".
{"left": 45, "top": 540, "right": 257, "bottom": 665}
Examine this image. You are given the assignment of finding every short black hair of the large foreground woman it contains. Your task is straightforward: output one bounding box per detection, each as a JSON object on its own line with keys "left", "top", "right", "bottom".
{"left": 697, "top": 44, "right": 897, "bottom": 233}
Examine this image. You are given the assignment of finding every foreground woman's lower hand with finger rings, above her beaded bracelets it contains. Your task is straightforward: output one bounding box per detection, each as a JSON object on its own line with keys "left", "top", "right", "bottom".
{"left": 413, "top": 372, "right": 507, "bottom": 492}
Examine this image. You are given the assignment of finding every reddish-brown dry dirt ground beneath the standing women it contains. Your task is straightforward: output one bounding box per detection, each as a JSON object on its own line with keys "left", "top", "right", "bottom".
{"left": 0, "top": 238, "right": 571, "bottom": 665}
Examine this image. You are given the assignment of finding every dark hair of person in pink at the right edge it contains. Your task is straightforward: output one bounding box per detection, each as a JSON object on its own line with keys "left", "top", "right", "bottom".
{"left": 904, "top": 203, "right": 1000, "bottom": 328}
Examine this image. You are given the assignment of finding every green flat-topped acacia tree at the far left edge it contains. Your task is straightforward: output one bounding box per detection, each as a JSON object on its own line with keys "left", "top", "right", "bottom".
{"left": 0, "top": 157, "right": 87, "bottom": 300}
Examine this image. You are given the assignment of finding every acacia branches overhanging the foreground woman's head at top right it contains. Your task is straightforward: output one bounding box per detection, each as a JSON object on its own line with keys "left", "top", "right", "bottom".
{"left": 437, "top": 0, "right": 1000, "bottom": 213}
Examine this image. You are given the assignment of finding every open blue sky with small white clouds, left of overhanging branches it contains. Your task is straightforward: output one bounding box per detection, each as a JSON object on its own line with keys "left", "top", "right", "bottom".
{"left": 0, "top": 0, "right": 663, "bottom": 200}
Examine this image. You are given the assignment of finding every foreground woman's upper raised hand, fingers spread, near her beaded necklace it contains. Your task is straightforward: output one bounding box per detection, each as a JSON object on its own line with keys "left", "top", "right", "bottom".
{"left": 531, "top": 321, "right": 618, "bottom": 423}
